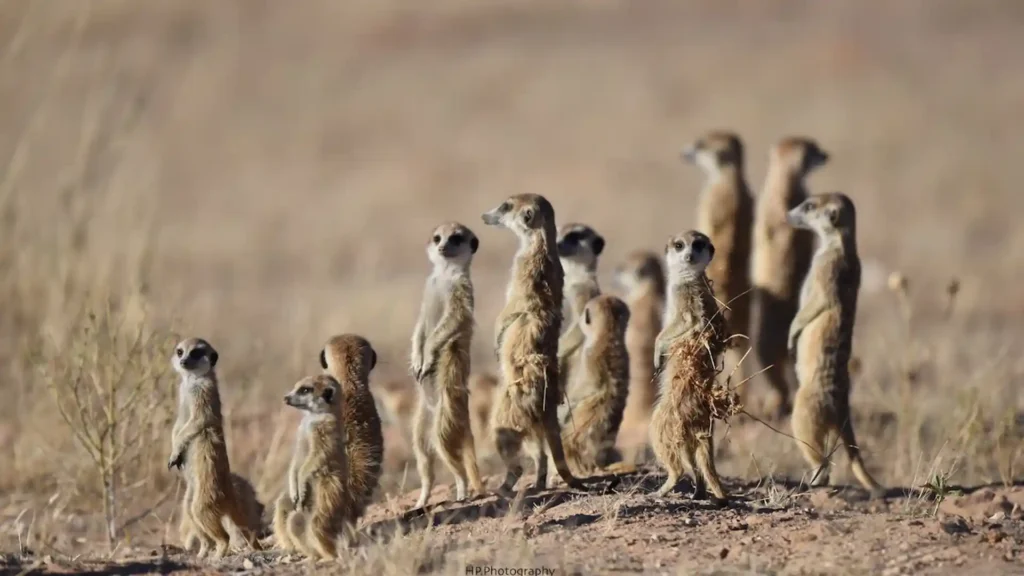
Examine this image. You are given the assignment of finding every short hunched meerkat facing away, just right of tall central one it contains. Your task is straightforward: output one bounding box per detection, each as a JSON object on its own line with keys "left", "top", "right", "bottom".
{"left": 562, "top": 294, "right": 630, "bottom": 476}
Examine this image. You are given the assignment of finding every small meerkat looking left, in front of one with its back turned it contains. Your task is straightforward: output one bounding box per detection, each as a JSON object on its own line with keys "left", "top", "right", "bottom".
{"left": 273, "top": 374, "right": 358, "bottom": 559}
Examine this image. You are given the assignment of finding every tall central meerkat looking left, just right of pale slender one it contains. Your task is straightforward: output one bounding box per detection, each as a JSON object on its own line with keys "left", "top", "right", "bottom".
{"left": 481, "top": 194, "right": 584, "bottom": 496}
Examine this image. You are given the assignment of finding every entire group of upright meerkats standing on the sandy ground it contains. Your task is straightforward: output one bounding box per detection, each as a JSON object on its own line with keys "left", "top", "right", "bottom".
{"left": 168, "top": 136, "right": 882, "bottom": 559}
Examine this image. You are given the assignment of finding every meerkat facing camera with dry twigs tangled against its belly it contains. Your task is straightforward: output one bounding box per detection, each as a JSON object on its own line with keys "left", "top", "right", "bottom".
{"left": 650, "top": 231, "right": 727, "bottom": 502}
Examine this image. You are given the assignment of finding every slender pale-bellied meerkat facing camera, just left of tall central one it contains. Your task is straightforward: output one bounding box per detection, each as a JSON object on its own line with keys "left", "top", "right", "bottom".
{"left": 411, "top": 222, "right": 483, "bottom": 508}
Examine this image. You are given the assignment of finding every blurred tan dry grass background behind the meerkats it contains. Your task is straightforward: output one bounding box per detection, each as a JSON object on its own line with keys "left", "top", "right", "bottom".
{"left": 0, "top": 0, "right": 1024, "bottom": 573}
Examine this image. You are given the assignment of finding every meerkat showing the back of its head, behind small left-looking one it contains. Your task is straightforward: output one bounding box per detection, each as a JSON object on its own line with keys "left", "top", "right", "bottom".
{"left": 319, "top": 334, "right": 384, "bottom": 517}
